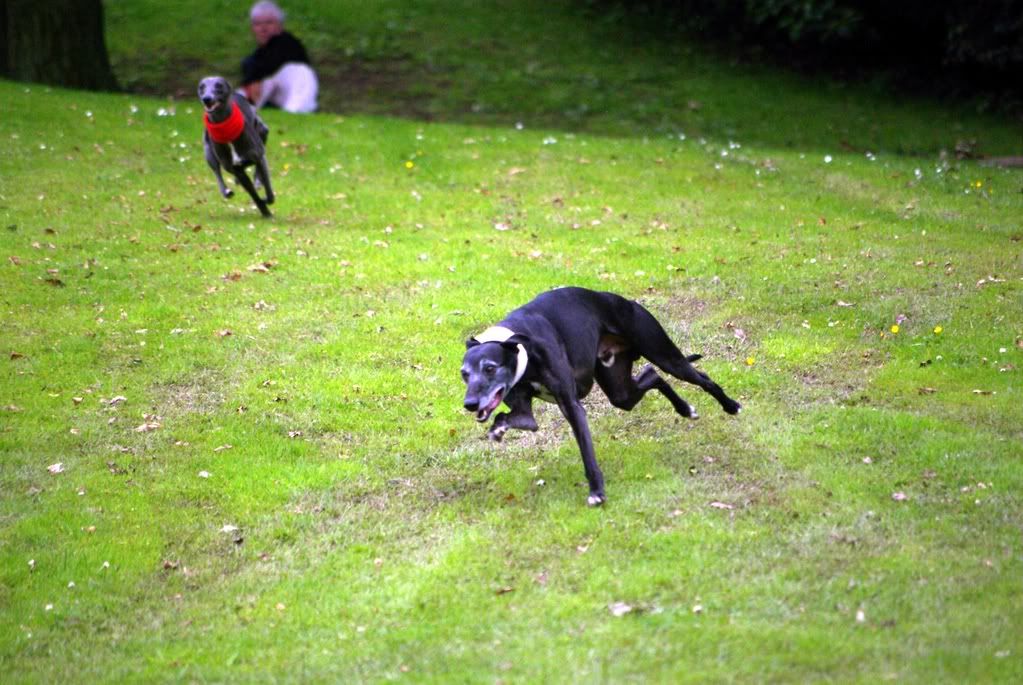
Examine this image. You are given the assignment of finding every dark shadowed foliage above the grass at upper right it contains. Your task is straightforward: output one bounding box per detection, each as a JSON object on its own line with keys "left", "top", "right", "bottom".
{"left": 584, "top": 0, "right": 1023, "bottom": 107}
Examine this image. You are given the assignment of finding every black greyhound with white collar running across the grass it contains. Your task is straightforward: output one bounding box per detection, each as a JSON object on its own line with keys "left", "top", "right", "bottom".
{"left": 461, "top": 287, "right": 741, "bottom": 506}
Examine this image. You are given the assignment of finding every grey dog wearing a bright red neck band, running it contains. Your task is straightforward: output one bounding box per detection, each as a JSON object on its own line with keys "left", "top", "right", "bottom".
{"left": 198, "top": 76, "right": 274, "bottom": 217}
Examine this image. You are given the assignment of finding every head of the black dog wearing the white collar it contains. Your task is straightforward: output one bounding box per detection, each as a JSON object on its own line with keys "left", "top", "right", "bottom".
{"left": 461, "top": 335, "right": 525, "bottom": 423}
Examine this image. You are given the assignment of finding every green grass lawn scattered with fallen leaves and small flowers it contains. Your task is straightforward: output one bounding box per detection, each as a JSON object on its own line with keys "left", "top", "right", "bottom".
{"left": 0, "top": 0, "right": 1023, "bottom": 683}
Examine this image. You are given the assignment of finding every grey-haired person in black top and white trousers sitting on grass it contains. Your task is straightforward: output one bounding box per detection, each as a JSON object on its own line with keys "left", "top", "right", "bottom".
{"left": 241, "top": 0, "right": 319, "bottom": 112}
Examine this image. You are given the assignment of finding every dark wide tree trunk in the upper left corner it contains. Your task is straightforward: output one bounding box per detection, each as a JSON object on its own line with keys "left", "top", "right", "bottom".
{"left": 0, "top": 0, "right": 118, "bottom": 90}
